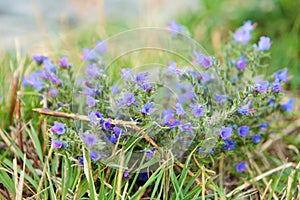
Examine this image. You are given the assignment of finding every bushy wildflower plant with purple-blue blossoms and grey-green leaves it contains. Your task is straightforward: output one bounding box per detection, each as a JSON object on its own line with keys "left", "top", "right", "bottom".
{"left": 23, "top": 21, "right": 294, "bottom": 177}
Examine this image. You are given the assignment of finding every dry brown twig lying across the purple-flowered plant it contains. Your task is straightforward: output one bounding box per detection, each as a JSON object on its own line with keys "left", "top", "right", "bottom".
{"left": 32, "top": 108, "right": 201, "bottom": 185}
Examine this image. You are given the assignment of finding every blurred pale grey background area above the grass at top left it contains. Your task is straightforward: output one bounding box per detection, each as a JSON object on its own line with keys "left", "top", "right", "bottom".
{"left": 0, "top": 0, "right": 198, "bottom": 51}
